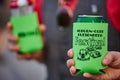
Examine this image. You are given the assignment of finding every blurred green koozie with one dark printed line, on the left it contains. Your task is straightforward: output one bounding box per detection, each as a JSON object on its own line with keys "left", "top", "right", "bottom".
{"left": 11, "top": 13, "right": 43, "bottom": 54}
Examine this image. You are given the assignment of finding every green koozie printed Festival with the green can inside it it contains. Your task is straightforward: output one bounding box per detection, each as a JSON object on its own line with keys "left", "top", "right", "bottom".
{"left": 73, "top": 15, "right": 108, "bottom": 75}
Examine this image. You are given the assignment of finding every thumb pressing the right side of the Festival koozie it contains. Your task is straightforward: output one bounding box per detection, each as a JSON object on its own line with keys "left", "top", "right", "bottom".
{"left": 103, "top": 51, "right": 120, "bottom": 68}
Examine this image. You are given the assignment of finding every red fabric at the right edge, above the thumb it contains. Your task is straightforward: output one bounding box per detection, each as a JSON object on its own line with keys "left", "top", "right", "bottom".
{"left": 106, "top": 0, "right": 120, "bottom": 31}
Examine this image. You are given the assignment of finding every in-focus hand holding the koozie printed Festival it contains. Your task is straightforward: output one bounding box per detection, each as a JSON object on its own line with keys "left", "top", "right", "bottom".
{"left": 67, "top": 49, "right": 120, "bottom": 80}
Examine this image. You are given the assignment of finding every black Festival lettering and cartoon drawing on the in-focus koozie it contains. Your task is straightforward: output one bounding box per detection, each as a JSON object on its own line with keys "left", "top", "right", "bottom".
{"left": 75, "top": 36, "right": 105, "bottom": 61}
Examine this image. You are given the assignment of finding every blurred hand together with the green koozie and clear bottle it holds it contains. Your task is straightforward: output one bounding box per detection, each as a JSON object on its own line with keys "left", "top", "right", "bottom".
{"left": 8, "top": 0, "right": 45, "bottom": 59}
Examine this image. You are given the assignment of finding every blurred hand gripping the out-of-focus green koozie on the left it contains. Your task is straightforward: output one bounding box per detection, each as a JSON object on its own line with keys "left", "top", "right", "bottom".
{"left": 7, "top": 22, "right": 46, "bottom": 62}
